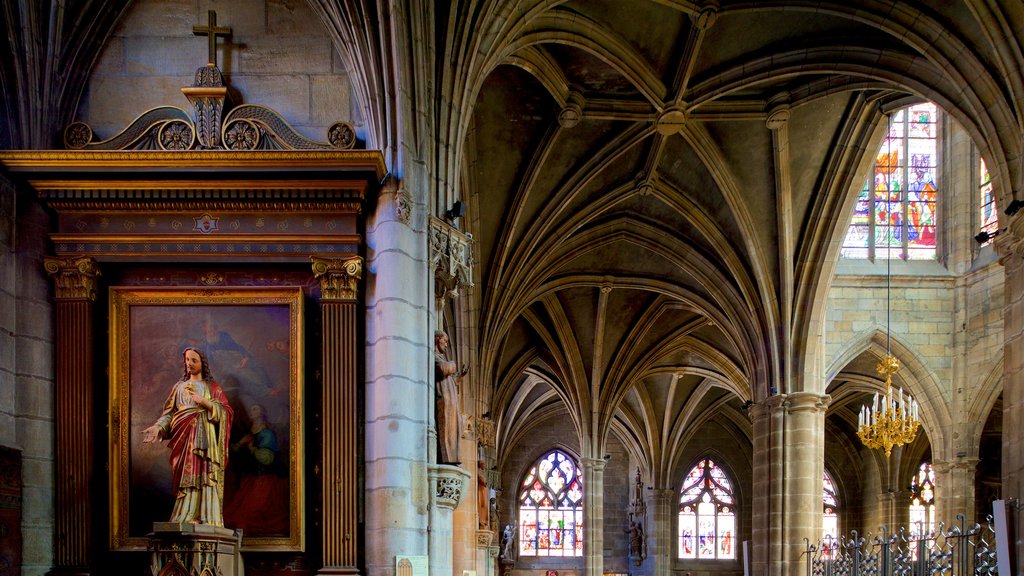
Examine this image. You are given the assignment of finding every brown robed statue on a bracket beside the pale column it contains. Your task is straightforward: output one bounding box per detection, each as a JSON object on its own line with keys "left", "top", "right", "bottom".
{"left": 434, "top": 330, "right": 467, "bottom": 465}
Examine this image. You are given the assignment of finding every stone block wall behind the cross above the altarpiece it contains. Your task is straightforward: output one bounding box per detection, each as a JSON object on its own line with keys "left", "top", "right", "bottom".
{"left": 77, "top": 0, "right": 361, "bottom": 141}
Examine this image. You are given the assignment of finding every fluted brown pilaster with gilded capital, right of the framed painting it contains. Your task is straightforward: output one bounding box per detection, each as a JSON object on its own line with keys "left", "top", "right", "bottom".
{"left": 311, "top": 256, "right": 362, "bottom": 574}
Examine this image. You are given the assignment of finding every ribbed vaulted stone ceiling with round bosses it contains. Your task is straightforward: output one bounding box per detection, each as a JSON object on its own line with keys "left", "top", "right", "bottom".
{"left": 0, "top": 0, "right": 1024, "bottom": 467}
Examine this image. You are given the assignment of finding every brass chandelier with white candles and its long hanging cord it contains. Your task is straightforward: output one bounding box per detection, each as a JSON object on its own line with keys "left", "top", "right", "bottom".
{"left": 857, "top": 109, "right": 921, "bottom": 458}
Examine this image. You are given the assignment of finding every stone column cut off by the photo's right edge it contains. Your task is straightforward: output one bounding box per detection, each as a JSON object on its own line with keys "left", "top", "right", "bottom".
{"left": 995, "top": 213, "right": 1024, "bottom": 574}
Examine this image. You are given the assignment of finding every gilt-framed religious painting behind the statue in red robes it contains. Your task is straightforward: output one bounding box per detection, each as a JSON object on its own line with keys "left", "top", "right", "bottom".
{"left": 110, "top": 287, "right": 305, "bottom": 551}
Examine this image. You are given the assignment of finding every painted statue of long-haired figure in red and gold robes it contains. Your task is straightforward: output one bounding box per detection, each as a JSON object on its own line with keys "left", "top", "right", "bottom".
{"left": 142, "top": 347, "right": 234, "bottom": 526}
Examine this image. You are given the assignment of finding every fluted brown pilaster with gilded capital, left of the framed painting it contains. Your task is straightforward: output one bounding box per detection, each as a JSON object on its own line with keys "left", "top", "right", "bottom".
{"left": 43, "top": 256, "right": 99, "bottom": 575}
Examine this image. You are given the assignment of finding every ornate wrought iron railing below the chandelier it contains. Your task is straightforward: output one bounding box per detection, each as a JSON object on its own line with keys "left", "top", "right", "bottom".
{"left": 806, "top": 515, "right": 998, "bottom": 576}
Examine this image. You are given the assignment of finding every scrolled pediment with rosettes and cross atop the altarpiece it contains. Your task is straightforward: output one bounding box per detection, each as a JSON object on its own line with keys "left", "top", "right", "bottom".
{"left": 63, "top": 10, "right": 356, "bottom": 151}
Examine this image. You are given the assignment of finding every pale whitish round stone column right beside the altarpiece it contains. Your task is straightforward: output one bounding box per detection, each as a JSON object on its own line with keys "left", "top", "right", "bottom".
{"left": 364, "top": 178, "right": 433, "bottom": 576}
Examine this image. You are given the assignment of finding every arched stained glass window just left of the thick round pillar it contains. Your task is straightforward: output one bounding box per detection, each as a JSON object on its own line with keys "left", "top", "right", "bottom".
{"left": 679, "top": 459, "right": 736, "bottom": 560}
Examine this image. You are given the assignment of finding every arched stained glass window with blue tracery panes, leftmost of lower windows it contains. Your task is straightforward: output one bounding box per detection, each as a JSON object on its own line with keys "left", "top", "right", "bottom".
{"left": 519, "top": 450, "right": 583, "bottom": 557}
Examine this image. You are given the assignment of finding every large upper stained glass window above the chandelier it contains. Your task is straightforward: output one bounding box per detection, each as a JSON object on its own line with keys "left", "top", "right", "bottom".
{"left": 842, "top": 102, "right": 939, "bottom": 259}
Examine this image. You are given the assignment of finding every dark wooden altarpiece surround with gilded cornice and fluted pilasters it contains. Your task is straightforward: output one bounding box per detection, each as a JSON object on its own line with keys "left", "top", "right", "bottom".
{"left": 0, "top": 144, "right": 385, "bottom": 574}
